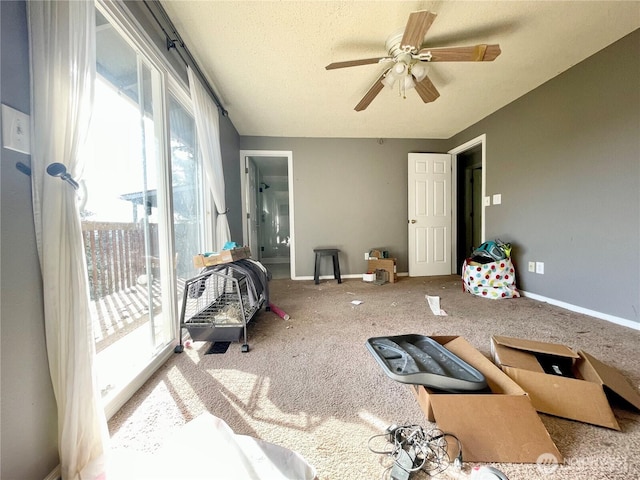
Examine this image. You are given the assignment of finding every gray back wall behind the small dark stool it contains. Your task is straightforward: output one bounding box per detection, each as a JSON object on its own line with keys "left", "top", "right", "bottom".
{"left": 240, "top": 137, "right": 446, "bottom": 276}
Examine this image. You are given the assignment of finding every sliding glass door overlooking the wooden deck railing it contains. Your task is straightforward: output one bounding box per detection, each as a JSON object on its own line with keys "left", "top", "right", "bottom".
{"left": 81, "top": 6, "right": 205, "bottom": 403}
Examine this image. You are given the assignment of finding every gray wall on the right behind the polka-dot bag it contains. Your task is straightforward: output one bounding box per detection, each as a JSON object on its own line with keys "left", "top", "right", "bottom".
{"left": 449, "top": 31, "right": 640, "bottom": 322}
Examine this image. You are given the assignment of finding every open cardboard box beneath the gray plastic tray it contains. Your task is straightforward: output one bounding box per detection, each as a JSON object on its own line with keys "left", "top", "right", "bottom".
{"left": 410, "top": 336, "right": 564, "bottom": 463}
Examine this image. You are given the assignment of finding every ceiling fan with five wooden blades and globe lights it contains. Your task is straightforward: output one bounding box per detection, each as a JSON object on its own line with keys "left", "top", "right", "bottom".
{"left": 325, "top": 10, "right": 501, "bottom": 112}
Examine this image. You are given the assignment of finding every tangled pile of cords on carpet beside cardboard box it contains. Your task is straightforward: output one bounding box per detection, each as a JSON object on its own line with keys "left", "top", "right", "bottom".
{"left": 368, "top": 425, "right": 462, "bottom": 476}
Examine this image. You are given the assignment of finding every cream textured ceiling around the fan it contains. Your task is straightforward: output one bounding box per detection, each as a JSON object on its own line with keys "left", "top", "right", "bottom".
{"left": 161, "top": 0, "right": 640, "bottom": 138}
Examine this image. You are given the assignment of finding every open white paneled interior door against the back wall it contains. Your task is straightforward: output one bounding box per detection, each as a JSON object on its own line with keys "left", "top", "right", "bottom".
{"left": 408, "top": 153, "right": 452, "bottom": 277}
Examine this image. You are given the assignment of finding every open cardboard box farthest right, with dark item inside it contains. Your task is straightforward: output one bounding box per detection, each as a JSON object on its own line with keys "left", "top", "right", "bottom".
{"left": 491, "top": 336, "right": 640, "bottom": 430}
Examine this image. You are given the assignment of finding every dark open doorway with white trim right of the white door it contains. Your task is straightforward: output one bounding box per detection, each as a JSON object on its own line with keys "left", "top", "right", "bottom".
{"left": 449, "top": 135, "right": 486, "bottom": 275}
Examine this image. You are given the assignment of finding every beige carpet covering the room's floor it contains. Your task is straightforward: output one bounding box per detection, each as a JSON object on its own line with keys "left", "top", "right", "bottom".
{"left": 109, "top": 276, "right": 640, "bottom": 480}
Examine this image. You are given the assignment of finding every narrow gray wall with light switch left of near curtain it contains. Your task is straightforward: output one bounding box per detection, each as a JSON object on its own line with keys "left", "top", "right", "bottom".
{"left": 0, "top": 2, "right": 58, "bottom": 480}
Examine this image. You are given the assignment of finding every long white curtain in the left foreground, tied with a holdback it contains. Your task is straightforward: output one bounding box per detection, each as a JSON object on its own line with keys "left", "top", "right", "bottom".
{"left": 25, "top": 0, "right": 108, "bottom": 480}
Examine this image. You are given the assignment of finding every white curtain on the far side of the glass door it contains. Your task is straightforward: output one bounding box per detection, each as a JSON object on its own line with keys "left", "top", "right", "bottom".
{"left": 187, "top": 67, "right": 231, "bottom": 251}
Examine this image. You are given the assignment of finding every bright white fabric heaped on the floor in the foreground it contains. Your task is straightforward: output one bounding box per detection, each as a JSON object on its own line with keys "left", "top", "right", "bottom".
{"left": 107, "top": 413, "right": 316, "bottom": 480}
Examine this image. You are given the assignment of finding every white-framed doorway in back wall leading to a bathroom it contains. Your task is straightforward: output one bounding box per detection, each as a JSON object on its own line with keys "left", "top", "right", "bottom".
{"left": 240, "top": 151, "right": 295, "bottom": 278}
